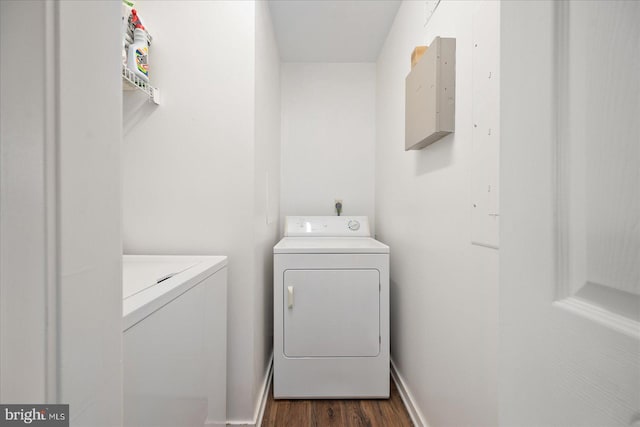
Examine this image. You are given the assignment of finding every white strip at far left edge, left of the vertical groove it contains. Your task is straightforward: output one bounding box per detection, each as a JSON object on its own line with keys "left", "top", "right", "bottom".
{"left": 0, "top": 1, "right": 51, "bottom": 403}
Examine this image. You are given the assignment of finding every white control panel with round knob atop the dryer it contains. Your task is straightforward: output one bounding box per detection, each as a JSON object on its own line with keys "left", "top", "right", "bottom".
{"left": 284, "top": 216, "right": 371, "bottom": 237}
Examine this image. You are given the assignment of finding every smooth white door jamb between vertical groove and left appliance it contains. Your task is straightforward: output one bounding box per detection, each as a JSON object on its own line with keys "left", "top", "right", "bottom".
{"left": 58, "top": 1, "right": 122, "bottom": 426}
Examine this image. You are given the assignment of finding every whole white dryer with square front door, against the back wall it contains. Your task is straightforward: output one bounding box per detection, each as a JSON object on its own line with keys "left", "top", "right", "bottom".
{"left": 273, "top": 216, "right": 389, "bottom": 399}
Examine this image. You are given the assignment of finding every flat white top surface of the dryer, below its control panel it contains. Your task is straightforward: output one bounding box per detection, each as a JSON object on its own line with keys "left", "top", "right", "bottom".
{"left": 273, "top": 237, "right": 389, "bottom": 254}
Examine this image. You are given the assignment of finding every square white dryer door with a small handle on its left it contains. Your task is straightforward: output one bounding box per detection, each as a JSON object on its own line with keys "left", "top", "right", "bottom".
{"left": 282, "top": 269, "right": 380, "bottom": 357}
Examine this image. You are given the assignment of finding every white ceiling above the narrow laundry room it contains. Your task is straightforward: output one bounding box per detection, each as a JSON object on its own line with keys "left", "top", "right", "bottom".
{"left": 269, "top": 0, "right": 400, "bottom": 62}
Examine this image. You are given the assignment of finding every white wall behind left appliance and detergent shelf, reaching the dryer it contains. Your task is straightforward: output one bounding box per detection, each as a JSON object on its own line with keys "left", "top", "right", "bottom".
{"left": 123, "top": 1, "right": 279, "bottom": 422}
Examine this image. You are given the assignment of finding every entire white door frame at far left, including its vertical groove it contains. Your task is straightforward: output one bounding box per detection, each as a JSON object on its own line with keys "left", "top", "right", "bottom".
{"left": 0, "top": 1, "right": 122, "bottom": 426}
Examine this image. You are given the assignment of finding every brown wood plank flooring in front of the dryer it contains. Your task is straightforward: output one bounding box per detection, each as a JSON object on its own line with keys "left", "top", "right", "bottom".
{"left": 262, "top": 380, "right": 413, "bottom": 427}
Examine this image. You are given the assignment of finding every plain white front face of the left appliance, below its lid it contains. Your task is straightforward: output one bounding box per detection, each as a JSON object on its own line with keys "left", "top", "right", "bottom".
{"left": 123, "top": 268, "right": 226, "bottom": 427}
